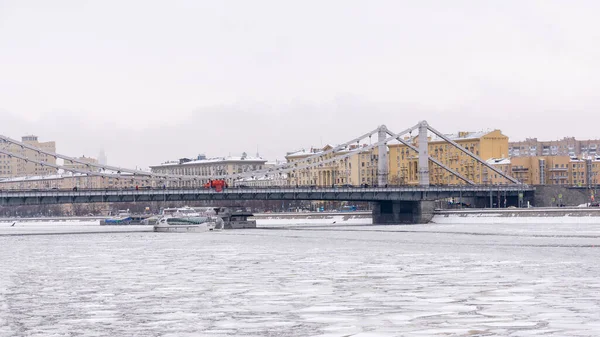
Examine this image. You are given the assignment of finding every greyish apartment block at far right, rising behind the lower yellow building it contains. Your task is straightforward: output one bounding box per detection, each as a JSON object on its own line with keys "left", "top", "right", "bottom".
{"left": 508, "top": 137, "right": 600, "bottom": 158}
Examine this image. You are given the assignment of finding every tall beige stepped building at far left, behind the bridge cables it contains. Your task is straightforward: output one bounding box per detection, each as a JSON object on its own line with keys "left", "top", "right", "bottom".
{"left": 0, "top": 135, "right": 56, "bottom": 178}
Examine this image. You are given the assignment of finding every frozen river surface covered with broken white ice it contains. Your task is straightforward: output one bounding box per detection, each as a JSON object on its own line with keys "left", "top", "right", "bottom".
{"left": 0, "top": 219, "right": 600, "bottom": 337}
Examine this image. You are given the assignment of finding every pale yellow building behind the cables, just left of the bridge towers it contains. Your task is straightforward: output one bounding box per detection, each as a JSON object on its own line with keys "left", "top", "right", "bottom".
{"left": 285, "top": 145, "right": 378, "bottom": 186}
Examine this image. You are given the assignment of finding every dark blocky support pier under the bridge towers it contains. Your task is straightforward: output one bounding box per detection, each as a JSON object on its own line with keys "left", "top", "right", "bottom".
{"left": 373, "top": 200, "right": 435, "bottom": 225}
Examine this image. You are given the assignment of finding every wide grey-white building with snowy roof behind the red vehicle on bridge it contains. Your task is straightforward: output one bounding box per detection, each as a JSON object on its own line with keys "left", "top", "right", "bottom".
{"left": 150, "top": 153, "right": 267, "bottom": 187}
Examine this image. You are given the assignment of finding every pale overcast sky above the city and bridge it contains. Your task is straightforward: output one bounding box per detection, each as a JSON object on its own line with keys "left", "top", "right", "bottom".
{"left": 0, "top": 0, "right": 600, "bottom": 168}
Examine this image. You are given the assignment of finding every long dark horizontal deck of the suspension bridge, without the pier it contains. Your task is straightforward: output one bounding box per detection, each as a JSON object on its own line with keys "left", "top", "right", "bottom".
{"left": 0, "top": 185, "right": 534, "bottom": 206}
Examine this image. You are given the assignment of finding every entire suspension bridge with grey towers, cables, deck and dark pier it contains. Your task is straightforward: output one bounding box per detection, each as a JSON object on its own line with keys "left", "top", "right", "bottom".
{"left": 0, "top": 121, "right": 534, "bottom": 223}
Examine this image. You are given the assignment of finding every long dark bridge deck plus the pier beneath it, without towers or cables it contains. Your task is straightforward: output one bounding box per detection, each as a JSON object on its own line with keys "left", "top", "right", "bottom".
{"left": 0, "top": 185, "right": 534, "bottom": 223}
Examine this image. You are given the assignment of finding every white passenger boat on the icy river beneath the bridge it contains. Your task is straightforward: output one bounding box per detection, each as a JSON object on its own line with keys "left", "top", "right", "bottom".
{"left": 154, "top": 207, "right": 223, "bottom": 232}
